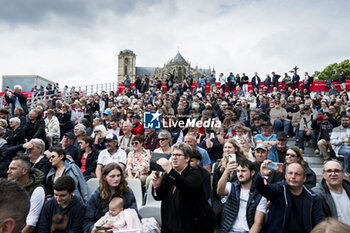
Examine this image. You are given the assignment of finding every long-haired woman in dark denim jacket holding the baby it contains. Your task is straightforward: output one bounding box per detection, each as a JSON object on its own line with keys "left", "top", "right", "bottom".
{"left": 84, "top": 163, "right": 140, "bottom": 232}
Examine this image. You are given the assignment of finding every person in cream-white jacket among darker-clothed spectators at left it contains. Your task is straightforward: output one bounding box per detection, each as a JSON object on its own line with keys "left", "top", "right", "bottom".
{"left": 45, "top": 109, "right": 60, "bottom": 146}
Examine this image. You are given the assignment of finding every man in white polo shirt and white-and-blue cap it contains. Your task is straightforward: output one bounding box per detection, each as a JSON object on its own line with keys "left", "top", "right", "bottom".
{"left": 95, "top": 133, "right": 126, "bottom": 178}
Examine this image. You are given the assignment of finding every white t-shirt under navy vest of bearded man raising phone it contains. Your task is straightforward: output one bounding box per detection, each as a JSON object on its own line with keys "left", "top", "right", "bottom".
{"left": 226, "top": 183, "right": 267, "bottom": 231}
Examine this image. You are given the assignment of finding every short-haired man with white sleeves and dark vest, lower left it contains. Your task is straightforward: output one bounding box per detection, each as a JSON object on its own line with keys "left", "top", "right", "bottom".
{"left": 7, "top": 156, "right": 45, "bottom": 233}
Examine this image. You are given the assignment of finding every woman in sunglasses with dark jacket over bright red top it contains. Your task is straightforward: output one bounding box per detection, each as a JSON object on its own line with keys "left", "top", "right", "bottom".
{"left": 77, "top": 136, "right": 100, "bottom": 181}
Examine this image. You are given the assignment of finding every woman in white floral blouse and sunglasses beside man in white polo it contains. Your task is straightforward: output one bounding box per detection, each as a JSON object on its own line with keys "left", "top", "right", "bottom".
{"left": 125, "top": 134, "right": 151, "bottom": 186}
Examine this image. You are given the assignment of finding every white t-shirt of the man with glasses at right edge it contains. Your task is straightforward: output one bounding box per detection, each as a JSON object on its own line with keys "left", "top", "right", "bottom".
{"left": 330, "top": 189, "right": 350, "bottom": 226}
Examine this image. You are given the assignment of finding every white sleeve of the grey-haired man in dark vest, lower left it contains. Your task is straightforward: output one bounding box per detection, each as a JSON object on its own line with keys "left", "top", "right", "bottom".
{"left": 26, "top": 186, "right": 45, "bottom": 227}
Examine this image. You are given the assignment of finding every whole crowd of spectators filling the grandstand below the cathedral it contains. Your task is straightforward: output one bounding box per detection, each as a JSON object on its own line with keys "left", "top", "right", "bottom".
{"left": 0, "top": 72, "right": 350, "bottom": 233}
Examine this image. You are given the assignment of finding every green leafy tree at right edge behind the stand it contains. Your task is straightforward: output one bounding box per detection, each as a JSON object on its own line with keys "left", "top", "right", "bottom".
{"left": 313, "top": 59, "right": 350, "bottom": 80}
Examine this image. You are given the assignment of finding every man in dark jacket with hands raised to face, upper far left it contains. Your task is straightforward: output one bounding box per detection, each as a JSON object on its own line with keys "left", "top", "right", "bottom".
{"left": 5, "top": 85, "right": 28, "bottom": 115}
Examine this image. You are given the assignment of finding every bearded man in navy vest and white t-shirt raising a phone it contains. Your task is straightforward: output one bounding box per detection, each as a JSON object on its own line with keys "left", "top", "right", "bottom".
{"left": 217, "top": 159, "right": 267, "bottom": 233}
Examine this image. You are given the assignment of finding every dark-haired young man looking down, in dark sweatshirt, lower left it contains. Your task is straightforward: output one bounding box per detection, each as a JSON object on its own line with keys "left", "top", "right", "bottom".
{"left": 39, "top": 176, "right": 85, "bottom": 233}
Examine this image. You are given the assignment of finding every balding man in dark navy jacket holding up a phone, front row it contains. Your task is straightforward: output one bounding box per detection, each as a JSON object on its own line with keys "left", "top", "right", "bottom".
{"left": 255, "top": 160, "right": 325, "bottom": 233}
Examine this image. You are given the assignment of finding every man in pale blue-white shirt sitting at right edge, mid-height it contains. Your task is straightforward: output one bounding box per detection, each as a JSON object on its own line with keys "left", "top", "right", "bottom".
{"left": 331, "top": 115, "right": 350, "bottom": 177}
